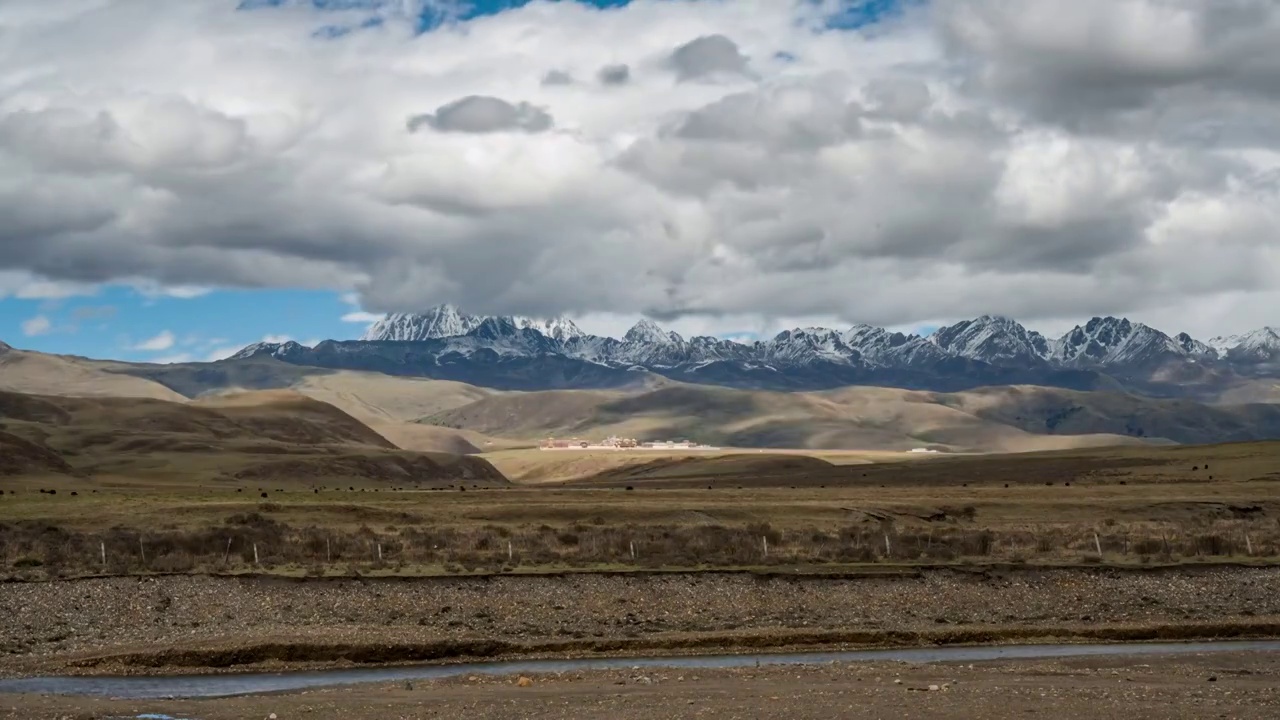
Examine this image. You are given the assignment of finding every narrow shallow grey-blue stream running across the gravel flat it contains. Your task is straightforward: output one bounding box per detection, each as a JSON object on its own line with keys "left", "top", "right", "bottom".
{"left": 0, "top": 641, "right": 1280, "bottom": 700}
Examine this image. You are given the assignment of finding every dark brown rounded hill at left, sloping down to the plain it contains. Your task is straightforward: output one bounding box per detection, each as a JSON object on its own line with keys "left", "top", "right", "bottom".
{"left": 0, "top": 391, "right": 506, "bottom": 487}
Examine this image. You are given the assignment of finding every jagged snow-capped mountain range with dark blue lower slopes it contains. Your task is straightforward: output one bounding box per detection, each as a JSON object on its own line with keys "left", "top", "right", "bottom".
{"left": 233, "top": 305, "right": 1280, "bottom": 396}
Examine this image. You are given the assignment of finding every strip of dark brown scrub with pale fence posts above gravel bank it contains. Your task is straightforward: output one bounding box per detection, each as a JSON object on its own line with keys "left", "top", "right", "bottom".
{"left": 0, "top": 512, "right": 1280, "bottom": 575}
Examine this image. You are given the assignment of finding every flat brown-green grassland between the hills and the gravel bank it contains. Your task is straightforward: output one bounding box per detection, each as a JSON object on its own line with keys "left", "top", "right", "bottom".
{"left": 0, "top": 435, "right": 1280, "bottom": 575}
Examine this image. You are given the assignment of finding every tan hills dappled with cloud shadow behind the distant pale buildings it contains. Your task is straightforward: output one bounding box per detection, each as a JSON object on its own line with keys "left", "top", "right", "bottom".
{"left": 422, "top": 386, "right": 1280, "bottom": 452}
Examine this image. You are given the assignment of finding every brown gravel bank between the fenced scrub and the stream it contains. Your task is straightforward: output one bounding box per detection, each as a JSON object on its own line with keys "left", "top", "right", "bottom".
{"left": 0, "top": 568, "right": 1280, "bottom": 674}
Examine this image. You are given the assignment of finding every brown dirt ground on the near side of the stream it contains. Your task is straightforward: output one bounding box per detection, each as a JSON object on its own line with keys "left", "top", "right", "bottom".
{"left": 0, "top": 653, "right": 1280, "bottom": 720}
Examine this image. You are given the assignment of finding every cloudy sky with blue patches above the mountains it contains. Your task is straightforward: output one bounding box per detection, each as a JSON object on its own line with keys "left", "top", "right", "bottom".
{"left": 0, "top": 0, "right": 1280, "bottom": 361}
